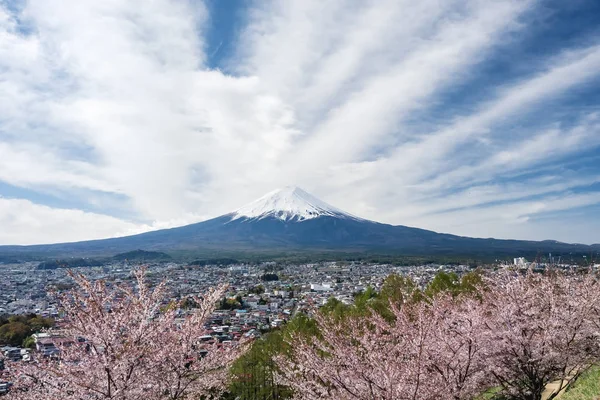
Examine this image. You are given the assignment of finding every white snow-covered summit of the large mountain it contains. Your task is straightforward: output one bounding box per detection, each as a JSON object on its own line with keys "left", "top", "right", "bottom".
{"left": 231, "top": 186, "right": 358, "bottom": 221}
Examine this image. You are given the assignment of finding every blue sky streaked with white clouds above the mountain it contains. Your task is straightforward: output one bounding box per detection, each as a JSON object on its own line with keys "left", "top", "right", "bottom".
{"left": 0, "top": 0, "right": 600, "bottom": 244}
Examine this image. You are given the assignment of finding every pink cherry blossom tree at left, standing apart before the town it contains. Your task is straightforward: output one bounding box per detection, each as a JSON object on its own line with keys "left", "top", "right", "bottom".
{"left": 4, "top": 269, "right": 244, "bottom": 400}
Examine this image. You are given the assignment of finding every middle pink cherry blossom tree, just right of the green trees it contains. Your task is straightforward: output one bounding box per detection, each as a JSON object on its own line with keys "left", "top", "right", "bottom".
{"left": 278, "top": 295, "right": 488, "bottom": 400}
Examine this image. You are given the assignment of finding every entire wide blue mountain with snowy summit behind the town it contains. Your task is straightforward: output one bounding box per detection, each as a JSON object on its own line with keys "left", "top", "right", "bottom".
{"left": 0, "top": 187, "right": 600, "bottom": 260}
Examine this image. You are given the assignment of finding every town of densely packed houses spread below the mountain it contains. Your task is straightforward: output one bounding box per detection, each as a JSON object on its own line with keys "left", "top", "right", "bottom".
{"left": 0, "top": 262, "right": 496, "bottom": 372}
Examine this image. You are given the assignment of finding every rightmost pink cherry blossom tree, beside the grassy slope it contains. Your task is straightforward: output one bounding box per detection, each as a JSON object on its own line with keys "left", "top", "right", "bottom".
{"left": 485, "top": 271, "right": 600, "bottom": 400}
